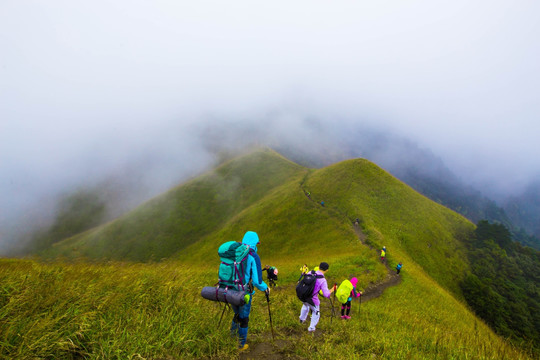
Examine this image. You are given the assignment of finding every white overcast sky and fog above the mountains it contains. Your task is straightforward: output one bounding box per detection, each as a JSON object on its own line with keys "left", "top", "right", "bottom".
{"left": 0, "top": 0, "right": 540, "bottom": 248}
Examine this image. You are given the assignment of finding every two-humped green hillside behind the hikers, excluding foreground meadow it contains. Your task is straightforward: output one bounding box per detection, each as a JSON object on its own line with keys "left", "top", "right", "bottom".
{"left": 44, "top": 150, "right": 474, "bottom": 294}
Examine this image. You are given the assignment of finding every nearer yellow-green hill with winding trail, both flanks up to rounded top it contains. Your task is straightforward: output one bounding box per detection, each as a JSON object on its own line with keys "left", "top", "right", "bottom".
{"left": 179, "top": 159, "right": 474, "bottom": 296}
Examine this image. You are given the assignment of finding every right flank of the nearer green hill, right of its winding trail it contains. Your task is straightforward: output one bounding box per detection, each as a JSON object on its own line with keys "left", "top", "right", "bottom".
{"left": 304, "top": 159, "right": 474, "bottom": 294}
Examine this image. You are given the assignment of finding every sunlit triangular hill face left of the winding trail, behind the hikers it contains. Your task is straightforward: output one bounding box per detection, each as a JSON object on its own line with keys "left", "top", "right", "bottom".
{"left": 179, "top": 169, "right": 372, "bottom": 266}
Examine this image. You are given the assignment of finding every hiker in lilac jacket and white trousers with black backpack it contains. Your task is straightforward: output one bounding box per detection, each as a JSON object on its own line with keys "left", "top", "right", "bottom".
{"left": 296, "top": 262, "right": 334, "bottom": 333}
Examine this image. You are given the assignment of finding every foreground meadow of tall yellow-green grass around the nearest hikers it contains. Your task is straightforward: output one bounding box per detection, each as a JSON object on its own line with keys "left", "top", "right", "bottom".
{"left": 0, "top": 258, "right": 533, "bottom": 360}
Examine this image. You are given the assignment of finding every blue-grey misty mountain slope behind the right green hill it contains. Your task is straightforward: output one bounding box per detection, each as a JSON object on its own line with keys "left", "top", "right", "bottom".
{"left": 277, "top": 128, "right": 540, "bottom": 249}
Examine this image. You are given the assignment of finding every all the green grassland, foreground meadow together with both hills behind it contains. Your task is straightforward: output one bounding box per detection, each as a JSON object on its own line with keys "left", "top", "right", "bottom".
{"left": 0, "top": 151, "right": 529, "bottom": 359}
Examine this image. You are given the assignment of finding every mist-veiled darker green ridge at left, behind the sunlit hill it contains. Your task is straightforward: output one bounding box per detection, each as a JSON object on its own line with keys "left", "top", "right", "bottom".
{"left": 42, "top": 150, "right": 305, "bottom": 261}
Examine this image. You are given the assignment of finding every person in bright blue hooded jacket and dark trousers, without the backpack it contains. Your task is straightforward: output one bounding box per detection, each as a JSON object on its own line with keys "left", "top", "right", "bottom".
{"left": 231, "top": 231, "right": 270, "bottom": 350}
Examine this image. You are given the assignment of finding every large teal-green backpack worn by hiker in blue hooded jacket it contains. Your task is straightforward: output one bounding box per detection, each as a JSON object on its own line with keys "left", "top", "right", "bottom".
{"left": 218, "top": 241, "right": 249, "bottom": 291}
